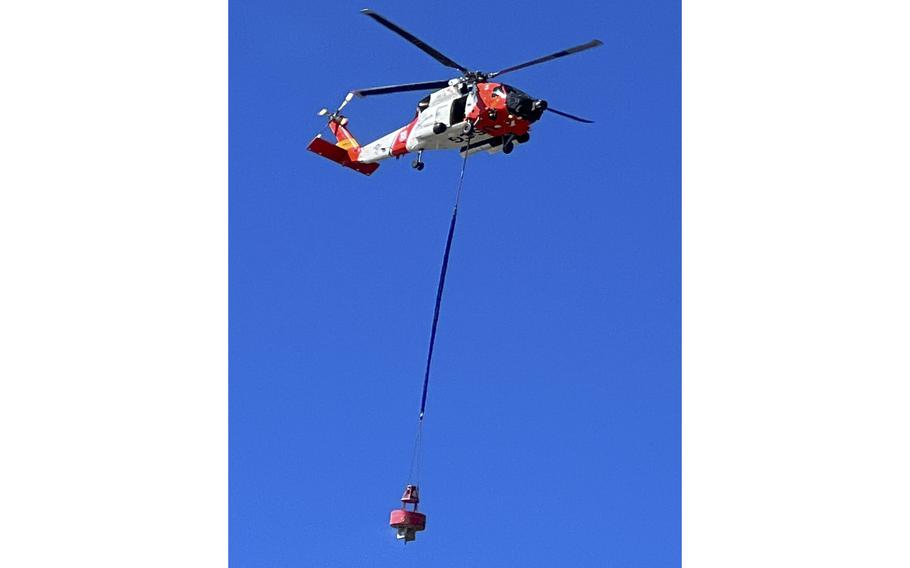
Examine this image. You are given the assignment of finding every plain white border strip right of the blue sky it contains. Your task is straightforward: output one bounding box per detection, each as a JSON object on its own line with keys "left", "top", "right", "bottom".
{"left": 683, "top": 0, "right": 910, "bottom": 568}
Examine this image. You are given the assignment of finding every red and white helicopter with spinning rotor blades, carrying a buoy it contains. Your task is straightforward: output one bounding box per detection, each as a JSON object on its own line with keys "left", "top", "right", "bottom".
{"left": 307, "top": 9, "right": 603, "bottom": 175}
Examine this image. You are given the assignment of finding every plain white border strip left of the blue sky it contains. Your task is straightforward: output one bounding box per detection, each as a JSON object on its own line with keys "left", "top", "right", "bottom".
{"left": 0, "top": 0, "right": 228, "bottom": 568}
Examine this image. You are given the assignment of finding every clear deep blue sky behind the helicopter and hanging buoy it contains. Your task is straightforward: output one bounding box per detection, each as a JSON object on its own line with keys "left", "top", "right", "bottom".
{"left": 230, "top": 0, "right": 680, "bottom": 567}
